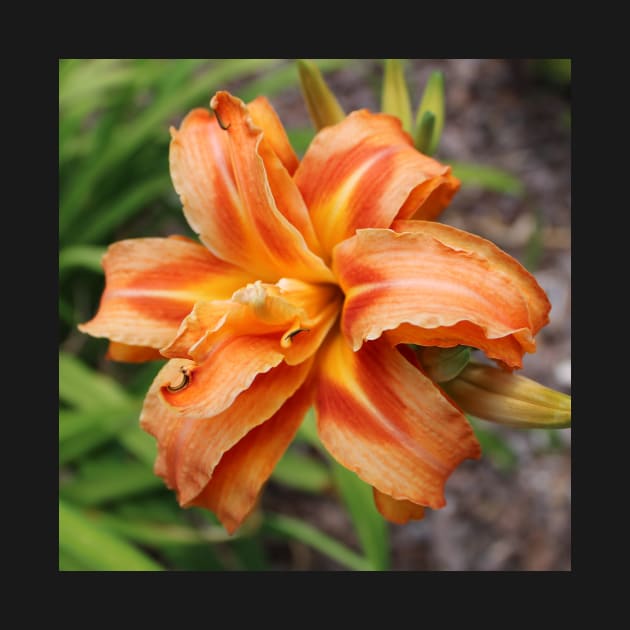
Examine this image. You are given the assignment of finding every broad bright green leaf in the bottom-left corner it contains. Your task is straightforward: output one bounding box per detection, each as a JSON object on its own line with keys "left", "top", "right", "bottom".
{"left": 59, "top": 501, "right": 162, "bottom": 571}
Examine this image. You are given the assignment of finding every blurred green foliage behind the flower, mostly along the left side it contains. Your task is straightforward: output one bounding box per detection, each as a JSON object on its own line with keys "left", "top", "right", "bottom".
{"left": 59, "top": 59, "right": 544, "bottom": 571}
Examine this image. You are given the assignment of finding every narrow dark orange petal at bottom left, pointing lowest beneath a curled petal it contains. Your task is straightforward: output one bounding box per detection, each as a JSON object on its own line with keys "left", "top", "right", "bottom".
{"left": 190, "top": 383, "right": 313, "bottom": 534}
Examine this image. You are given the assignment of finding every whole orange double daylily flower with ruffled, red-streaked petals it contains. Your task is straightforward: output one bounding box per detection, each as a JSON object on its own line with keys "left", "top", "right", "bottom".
{"left": 80, "top": 92, "right": 550, "bottom": 532}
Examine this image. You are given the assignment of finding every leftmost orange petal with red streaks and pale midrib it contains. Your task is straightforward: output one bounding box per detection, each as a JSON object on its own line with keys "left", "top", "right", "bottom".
{"left": 79, "top": 237, "right": 251, "bottom": 353}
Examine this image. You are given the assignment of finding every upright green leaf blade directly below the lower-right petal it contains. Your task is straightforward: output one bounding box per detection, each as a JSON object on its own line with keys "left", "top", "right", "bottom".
{"left": 332, "top": 462, "right": 389, "bottom": 571}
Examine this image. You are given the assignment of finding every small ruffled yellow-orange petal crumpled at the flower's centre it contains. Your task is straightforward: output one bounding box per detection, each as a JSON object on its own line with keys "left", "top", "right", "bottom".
{"left": 162, "top": 278, "right": 341, "bottom": 365}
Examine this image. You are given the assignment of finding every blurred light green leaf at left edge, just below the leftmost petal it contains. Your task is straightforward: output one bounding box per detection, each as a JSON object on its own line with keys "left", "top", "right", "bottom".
{"left": 59, "top": 352, "right": 130, "bottom": 409}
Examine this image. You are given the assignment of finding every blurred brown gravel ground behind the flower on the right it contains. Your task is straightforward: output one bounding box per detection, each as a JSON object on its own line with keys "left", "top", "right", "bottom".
{"left": 263, "top": 59, "right": 571, "bottom": 571}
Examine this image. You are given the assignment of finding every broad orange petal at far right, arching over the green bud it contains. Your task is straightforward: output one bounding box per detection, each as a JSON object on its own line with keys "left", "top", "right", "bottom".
{"left": 333, "top": 230, "right": 536, "bottom": 367}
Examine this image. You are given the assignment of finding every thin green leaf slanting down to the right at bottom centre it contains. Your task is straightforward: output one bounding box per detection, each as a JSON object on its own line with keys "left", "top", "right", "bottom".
{"left": 263, "top": 512, "right": 374, "bottom": 571}
